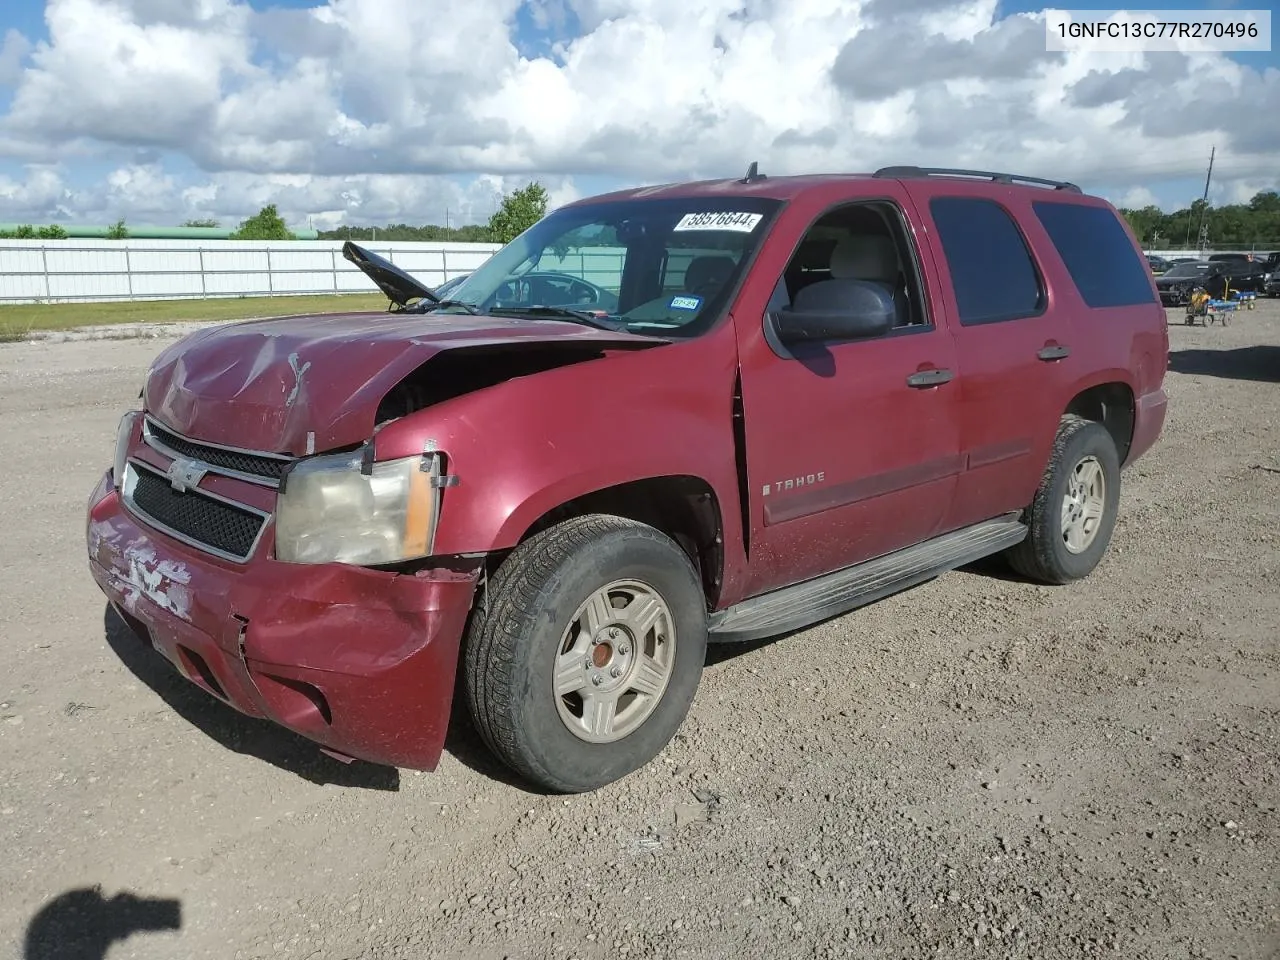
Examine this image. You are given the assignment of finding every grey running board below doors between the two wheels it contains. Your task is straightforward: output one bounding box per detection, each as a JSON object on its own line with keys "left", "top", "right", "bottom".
{"left": 708, "top": 513, "right": 1027, "bottom": 644}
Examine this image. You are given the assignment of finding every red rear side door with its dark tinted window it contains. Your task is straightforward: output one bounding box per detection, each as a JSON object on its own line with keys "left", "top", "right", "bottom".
{"left": 909, "top": 180, "right": 1079, "bottom": 529}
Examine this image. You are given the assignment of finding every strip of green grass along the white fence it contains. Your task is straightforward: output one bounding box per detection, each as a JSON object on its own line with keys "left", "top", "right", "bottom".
{"left": 0, "top": 293, "right": 387, "bottom": 343}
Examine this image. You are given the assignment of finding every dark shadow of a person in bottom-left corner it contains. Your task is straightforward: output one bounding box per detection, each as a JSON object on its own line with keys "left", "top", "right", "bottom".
{"left": 22, "top": 887, "right": 182, "bottom": 960}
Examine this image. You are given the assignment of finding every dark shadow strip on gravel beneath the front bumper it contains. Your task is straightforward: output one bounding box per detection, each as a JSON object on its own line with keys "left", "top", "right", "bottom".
{"left": 102, "top": 604, "right": 399, "bottom": 791}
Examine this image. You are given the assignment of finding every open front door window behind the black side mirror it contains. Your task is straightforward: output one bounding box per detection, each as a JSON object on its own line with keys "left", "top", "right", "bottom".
{"left": 769, "top": 201, "right": 932, "bottom": 329}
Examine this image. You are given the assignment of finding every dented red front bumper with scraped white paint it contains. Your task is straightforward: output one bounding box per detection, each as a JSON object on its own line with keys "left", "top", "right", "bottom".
{"left": 86, "top": 475, "right": 479, "bottom": 771}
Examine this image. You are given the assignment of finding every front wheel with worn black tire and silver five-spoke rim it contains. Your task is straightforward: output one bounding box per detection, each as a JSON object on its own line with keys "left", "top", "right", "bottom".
{"left": 463, "top": 515, "right": 707, "bottom": 794}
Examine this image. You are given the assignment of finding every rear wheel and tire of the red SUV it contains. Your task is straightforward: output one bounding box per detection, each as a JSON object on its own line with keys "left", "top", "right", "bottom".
{"left": 1006, "top": 415, "right": 1120, "bottom": 585}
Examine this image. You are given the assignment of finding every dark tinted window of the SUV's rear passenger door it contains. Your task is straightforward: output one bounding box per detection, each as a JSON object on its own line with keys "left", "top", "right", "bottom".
{"left": 929, "top": 197, "right": 1046, "bottom": 326}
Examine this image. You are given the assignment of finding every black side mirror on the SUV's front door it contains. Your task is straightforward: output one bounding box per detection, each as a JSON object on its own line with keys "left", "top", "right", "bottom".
{"left": 774, "top": 280, "right": 897, "bottom": 343}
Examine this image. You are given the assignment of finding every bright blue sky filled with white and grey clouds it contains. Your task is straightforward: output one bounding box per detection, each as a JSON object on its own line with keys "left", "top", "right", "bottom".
{"left": 0, "top": 0, "right": 1280, "bottom": 229}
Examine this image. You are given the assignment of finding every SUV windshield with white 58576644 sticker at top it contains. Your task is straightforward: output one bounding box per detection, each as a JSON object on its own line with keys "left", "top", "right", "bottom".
{"left": 442, "top": 197, "right": 781, "bottom": 337}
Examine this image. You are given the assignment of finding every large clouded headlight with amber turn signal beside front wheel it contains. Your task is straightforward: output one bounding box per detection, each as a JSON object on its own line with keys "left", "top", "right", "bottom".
{"left": 275, "top": 451, "right": 440, "bottom": 566}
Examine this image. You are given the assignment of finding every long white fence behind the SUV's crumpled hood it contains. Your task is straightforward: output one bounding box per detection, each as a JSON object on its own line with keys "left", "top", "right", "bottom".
{"left": 0, "top": 239, "right": 499, "bottom": 303}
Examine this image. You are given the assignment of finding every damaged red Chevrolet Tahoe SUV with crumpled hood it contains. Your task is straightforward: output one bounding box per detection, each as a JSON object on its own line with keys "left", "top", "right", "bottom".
{"left": 87, "top": 164, "right": 1169, "bottom": 791}
